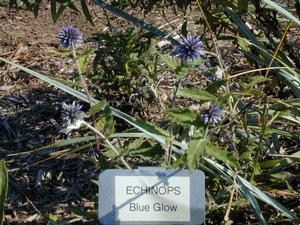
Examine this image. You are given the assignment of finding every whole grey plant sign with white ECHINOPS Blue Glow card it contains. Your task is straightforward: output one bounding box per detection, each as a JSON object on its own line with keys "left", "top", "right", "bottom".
{"left": 99, "top": 167, "right": 205, "bottom": 225}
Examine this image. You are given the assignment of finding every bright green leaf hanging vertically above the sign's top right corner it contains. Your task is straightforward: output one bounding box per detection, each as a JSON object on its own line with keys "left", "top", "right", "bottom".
{"left": 187, "top": 133, "right": 208, "bottom": 171}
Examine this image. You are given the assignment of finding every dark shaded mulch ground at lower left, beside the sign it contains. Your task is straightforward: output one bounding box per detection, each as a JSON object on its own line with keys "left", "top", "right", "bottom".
{"left": 0, "top": 88, "right": 99, "bottom": 225}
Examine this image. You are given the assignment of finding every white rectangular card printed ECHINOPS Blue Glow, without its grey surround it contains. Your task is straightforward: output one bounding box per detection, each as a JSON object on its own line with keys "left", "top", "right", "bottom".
{"left": 115, "top": 176, "right": 191, "bottom": 222}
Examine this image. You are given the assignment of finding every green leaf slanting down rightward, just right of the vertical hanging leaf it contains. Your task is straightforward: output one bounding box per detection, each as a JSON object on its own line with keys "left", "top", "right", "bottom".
{"left": 205, "top": 142, "right": 240, "bottom": 168}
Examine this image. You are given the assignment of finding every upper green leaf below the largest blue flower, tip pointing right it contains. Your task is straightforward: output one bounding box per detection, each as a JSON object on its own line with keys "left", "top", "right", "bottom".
{"left": 178, "top": 87, "right": 216, "bottom": 102}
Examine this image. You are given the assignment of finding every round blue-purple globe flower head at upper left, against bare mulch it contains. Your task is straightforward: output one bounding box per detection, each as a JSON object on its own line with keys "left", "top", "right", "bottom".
{"left": 58, "top": 25, "right": 82, "bottom": 49}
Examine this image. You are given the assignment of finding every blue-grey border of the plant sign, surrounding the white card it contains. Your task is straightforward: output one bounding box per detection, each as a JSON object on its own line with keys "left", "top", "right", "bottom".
{"left": 99, "top": 167, "right": 205, "bottom": 225}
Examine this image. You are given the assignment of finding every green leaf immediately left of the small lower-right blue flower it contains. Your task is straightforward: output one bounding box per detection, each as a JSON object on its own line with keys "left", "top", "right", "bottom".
{"left": 166, "top": 108, "right": 201, "bottom": 125}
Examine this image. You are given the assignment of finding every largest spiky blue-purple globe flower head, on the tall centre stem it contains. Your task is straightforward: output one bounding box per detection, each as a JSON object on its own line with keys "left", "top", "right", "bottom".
{"left": 176, "top": 36, "right": 204, "bottom": 63}
